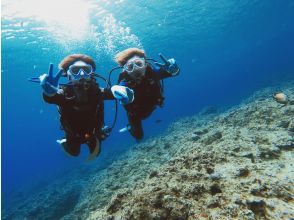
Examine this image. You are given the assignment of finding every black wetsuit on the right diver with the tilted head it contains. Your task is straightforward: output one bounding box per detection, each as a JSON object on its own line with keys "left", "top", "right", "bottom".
{"left": 119, "top": 65, "right": 171, "bottom": 140}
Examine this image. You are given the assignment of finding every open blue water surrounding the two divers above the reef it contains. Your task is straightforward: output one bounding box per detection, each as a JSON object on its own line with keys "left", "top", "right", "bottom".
{"left": 1, "top": 0, "right": 294, "bottom": 199}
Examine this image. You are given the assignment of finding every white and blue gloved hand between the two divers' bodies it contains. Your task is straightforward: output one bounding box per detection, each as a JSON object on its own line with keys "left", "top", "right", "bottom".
{"left": 111, "top": 85, "right": 134, "bottom": 105}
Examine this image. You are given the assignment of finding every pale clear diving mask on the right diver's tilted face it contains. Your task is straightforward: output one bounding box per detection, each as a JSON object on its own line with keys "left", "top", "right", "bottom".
{"left": 123, "top": 56, "right": 146, "bottom": 79}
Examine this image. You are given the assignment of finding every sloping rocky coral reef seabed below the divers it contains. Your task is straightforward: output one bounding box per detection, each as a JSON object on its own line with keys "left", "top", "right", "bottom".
{"left": 2, "top": 82, "right": 294, "bottom": 220}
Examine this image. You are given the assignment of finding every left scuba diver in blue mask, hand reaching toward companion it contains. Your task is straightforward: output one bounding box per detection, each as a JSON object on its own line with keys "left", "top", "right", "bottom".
{"left": 35, "top": 54, "right": 134, "bottom": 160}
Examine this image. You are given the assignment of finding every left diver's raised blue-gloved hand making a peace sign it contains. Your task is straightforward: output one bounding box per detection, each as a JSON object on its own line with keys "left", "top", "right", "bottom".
{"left": 39, "top": 63, "right": 63, "bottom": 96}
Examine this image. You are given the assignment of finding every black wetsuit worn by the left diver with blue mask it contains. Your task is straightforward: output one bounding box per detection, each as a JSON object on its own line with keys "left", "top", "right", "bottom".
{"left": 43, "top": 82, "right": 114, "bottom": 156}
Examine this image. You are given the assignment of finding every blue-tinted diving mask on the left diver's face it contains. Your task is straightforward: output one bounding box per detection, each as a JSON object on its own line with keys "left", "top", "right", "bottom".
{"left": 67, "top": 61, "right": 93, "bottom": 80}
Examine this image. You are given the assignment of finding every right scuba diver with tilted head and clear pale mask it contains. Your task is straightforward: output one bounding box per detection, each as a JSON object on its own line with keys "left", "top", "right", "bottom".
{"left": 115, "top": 48, "right": 180, "bottom": 140}
